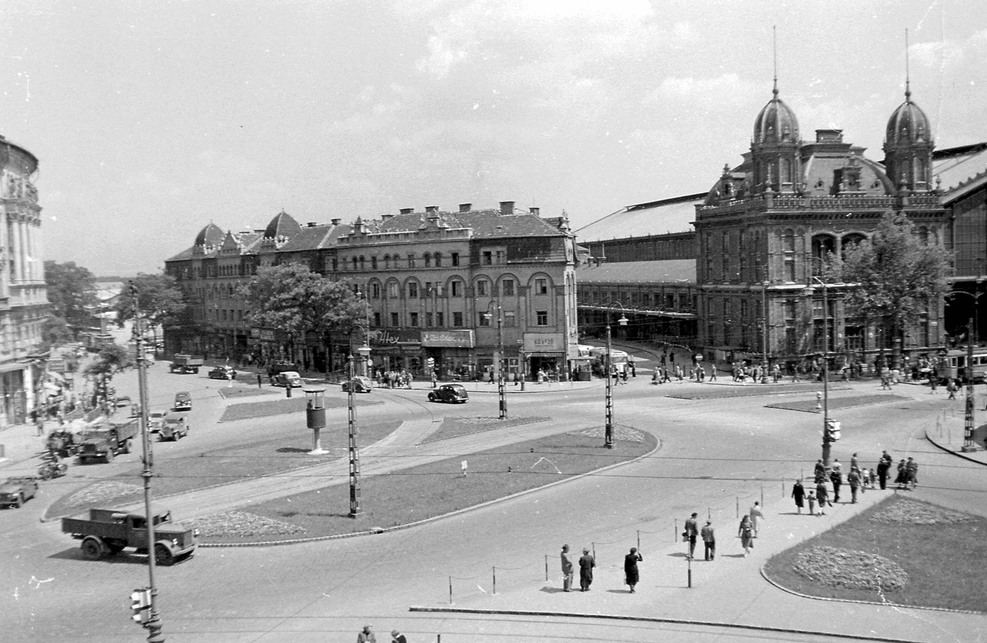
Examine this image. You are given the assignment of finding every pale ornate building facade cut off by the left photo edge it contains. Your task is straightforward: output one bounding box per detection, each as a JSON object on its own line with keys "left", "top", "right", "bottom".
{"left": 0, "top": 136, "right": 48, "bottom": 425}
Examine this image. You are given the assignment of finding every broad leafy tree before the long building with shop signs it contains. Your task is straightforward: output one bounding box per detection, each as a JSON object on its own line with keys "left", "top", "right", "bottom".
{"left": 240, "top": 263, "right": 369, "bottom": 370}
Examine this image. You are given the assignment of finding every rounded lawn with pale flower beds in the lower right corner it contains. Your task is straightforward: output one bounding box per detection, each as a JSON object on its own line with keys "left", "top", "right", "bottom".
{"left": 764, "top": 494, "right": 987, "bottom": 612}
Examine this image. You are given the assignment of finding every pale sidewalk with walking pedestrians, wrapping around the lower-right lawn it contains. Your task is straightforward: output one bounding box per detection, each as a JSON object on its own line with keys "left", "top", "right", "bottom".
{"left": 410, "top": 490, "right": 984, "bottom": 641}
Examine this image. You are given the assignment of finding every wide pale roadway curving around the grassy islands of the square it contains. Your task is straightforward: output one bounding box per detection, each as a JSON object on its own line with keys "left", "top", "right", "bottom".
{"left": 0, "top": 363, "right": 987, "bottom": 643}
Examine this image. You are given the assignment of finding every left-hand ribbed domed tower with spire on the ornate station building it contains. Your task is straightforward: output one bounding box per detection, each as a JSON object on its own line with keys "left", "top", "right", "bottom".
{"left": 751, "top": 78, "right": 802, "bottom": 194}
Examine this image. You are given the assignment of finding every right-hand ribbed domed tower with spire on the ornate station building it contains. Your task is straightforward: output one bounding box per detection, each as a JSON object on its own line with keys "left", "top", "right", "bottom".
{"left": 884, "top": 80, "right": 935, "bottom": 192}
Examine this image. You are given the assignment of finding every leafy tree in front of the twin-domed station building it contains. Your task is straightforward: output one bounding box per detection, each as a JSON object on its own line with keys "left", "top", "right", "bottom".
{"left": 825, "top": 213, "right": 950, "bottom": 350}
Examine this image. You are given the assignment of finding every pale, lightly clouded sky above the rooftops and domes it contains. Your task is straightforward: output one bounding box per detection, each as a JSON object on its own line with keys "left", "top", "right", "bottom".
{"left": 0, "top": 0, "right": 987, "bottom": 276}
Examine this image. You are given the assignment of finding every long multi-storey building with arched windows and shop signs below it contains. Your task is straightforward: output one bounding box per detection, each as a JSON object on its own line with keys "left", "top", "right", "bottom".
{"left": 165, "top": 201, "right": 577, "bottom": 378}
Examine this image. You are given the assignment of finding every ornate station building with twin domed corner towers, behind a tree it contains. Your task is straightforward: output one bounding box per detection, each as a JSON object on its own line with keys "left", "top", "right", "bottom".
{"left": 694, "top": 80, "right": 950, "bottom": 363}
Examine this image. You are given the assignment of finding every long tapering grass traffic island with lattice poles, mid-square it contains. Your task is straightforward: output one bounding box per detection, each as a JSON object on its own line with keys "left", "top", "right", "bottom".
{"left": 190, "top": 427, "right": 657, "bottom": 544}
